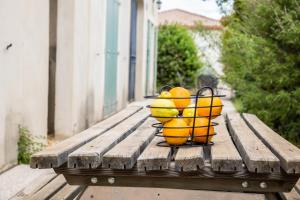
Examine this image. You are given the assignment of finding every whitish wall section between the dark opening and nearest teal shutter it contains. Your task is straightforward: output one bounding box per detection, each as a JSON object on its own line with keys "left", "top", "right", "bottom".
{"left": 55, "top": 0, "right": 106, "bottom": 138}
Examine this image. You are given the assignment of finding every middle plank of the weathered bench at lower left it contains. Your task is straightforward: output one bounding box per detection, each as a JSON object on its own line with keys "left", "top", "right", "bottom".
{"left": 25, "top": 175, "right": 67, "bottom": 200}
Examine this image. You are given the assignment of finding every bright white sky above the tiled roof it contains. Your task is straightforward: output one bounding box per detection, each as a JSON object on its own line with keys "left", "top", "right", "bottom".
{"left": 161, "top": 0, "right": 222, "bottom": 19}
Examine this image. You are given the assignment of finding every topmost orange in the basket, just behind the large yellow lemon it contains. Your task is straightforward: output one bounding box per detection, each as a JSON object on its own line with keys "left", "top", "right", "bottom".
{"left": 169, "top": 87, "right": 191, "bottom": 111}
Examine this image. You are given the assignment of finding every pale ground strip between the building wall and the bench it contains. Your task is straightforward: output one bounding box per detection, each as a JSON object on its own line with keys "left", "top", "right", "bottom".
{"left": 0, "top": 165, "right": 53, "bottom": 200}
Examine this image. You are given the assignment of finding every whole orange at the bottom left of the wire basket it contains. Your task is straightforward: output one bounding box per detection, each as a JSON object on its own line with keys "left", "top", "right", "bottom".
{"left": 163, "top": 118, "right": 190, "bottom": 145}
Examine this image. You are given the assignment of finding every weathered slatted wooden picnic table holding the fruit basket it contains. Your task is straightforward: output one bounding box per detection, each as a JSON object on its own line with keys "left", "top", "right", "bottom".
{"left": 31, "top": 102, "right": 300, "bottom": 196}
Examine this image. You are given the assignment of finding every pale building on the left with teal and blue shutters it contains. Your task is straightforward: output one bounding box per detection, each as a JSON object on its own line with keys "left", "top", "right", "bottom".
{"left": 0, "top": 0, "right": 158, "bottom": 171}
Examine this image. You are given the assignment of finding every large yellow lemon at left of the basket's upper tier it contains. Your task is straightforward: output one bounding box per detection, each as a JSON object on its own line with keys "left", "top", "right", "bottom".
{"left": 150, "top": 99, "right": 179, "bottom": 123}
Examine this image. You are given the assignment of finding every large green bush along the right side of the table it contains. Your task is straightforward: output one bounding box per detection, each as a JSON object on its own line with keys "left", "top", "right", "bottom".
{"left": 222, "top": 0, "right": 300, "bottom": 145}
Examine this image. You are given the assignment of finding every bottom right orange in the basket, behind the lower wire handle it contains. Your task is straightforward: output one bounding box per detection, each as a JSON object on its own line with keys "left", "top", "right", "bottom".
{"left": 190, "top": 117, "right": 214, "bottom": 143}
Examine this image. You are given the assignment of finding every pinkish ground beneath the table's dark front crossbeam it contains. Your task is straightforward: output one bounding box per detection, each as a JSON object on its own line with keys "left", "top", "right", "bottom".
{"left": 80, "top": 186, "right": 265, "bottom": 200}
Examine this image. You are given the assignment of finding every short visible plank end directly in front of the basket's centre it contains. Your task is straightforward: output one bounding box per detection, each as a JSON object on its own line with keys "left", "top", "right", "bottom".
{"left": 175, "top": 146, "right": 204, "bottom": 171}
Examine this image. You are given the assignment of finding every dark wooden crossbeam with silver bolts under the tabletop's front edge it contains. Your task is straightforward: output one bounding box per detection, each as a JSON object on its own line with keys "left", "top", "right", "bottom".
{"left": 59, "top": 170, "right": 298, "bottom": 193}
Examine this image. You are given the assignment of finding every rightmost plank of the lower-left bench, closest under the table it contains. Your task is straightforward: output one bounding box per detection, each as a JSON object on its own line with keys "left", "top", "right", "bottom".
{"left": 50, "top": 185, "right": 84, "bottom": 200}
